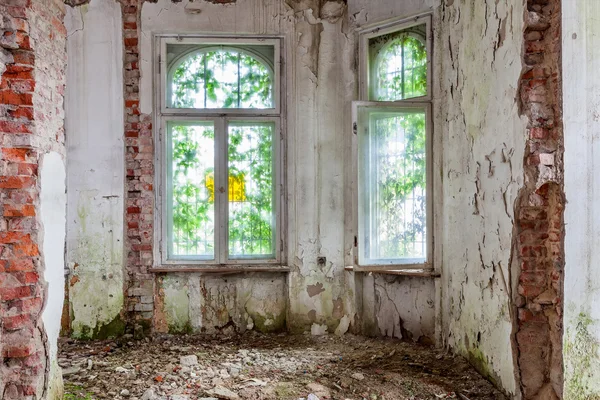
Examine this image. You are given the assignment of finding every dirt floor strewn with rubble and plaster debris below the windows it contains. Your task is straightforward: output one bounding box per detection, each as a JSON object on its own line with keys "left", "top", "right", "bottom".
{"left": 59, "top": 333, "right": 505, "bottom": 400}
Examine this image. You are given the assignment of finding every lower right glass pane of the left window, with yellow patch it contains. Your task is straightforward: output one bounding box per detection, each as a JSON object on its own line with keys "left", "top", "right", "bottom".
{"left": 228, "top": 122, "right": 275, "bottom": 259}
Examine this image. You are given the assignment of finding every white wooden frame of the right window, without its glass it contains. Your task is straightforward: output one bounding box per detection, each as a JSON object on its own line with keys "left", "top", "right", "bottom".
{"left": 351, "top": 13, "right": 435, "bottom": 272}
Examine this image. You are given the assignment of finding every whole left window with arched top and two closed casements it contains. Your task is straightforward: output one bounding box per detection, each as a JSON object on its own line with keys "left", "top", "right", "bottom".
{"left": 155, "top": 35, "right": 285, "bottom": 269}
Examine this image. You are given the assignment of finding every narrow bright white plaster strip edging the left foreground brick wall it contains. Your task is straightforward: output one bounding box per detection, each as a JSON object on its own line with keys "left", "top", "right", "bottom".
{"left": 40, "top": 152, "right": 67, "bottom": 393}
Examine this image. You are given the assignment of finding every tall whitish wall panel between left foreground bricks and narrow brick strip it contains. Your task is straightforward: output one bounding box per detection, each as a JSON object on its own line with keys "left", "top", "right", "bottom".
{"left": 65, "top": 0, "right": 125, "bottom": 336}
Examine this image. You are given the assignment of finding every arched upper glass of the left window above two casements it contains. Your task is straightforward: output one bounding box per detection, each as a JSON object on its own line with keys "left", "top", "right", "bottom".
{"left": 167, "top": 46, "right": 274, "bottom": 109}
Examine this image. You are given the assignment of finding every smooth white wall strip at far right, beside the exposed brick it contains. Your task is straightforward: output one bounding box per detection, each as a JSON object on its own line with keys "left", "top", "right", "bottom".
{"left": 562, "top": 0, "right": 600, "bottom": 400}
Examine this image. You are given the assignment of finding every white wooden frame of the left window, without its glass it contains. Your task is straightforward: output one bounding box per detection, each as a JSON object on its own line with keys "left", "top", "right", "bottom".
{"left": 152, "top": 34, "right": 287, "bottom": 271}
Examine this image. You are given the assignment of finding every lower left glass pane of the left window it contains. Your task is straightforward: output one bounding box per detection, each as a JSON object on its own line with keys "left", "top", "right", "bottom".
{"left": 167, "top": 122, "right": 215, "bottom": 260}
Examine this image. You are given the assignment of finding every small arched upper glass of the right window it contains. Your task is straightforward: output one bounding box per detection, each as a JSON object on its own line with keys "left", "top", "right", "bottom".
{"left": 370, "top": 30, "right": 427, "bottom": 101}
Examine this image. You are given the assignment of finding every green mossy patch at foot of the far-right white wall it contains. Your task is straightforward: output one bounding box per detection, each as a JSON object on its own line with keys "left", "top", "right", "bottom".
{"left": 564, "top": 313, "right": 600, "bottom": 400}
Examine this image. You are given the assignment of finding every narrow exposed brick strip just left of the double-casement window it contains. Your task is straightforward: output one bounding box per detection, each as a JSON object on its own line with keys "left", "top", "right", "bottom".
{"left": 121, "top": 0, "right": 154, "bottom": 337}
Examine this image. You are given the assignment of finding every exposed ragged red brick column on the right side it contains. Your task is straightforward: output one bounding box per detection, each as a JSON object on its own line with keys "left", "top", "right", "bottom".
{"left": 515, "top": 0, "right": 565, "bottom": 400}
